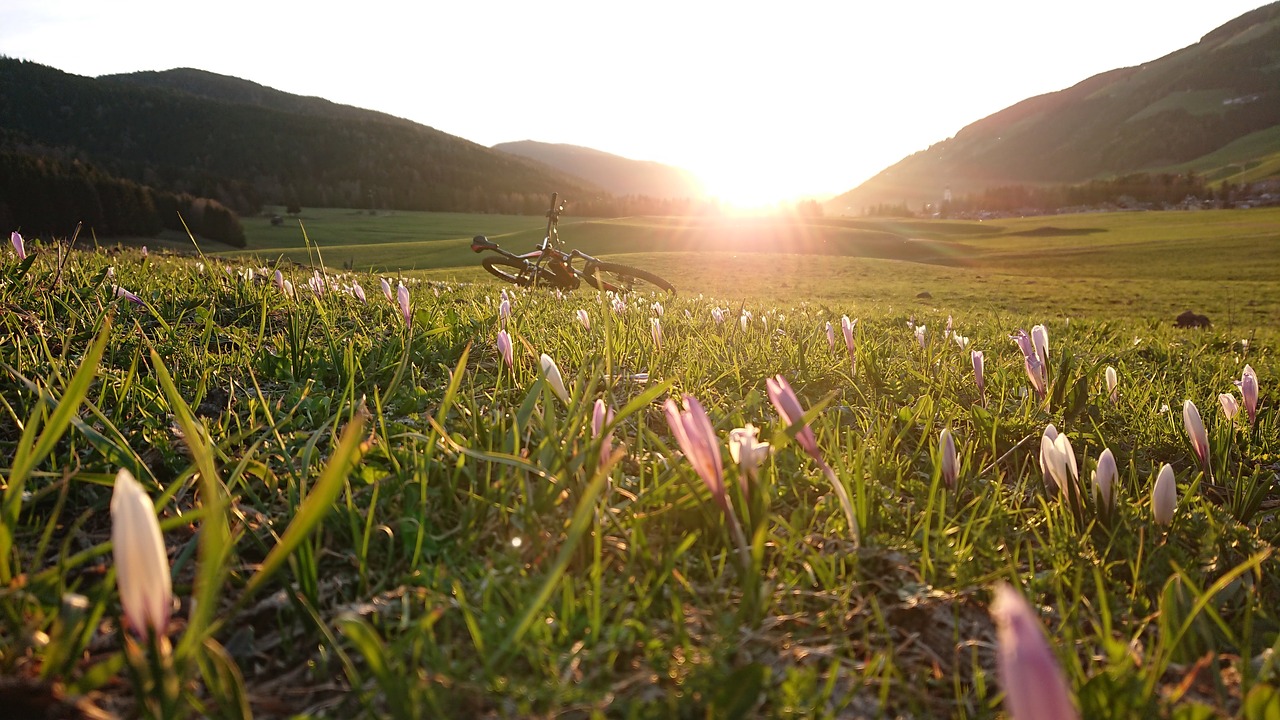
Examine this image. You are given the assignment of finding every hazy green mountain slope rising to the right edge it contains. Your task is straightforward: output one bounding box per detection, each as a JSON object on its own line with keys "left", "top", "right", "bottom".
{"left": 827, "top": 3, "right": 1280, "bottom": 214}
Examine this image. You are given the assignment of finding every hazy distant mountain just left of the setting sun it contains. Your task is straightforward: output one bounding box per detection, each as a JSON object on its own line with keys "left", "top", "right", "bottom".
{"left": 493, "top": 140, "right": 704, "bottom": 199}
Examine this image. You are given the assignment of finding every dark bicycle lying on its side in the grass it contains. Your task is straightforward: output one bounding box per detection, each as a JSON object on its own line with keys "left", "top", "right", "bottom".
{"left": 471, "top": 192, "right": 676, "bottom": 295}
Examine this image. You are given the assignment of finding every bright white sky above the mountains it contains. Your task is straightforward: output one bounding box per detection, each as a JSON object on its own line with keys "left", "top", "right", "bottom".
{"left": 0, "top": 0, "right": 1263, "bottom": 205}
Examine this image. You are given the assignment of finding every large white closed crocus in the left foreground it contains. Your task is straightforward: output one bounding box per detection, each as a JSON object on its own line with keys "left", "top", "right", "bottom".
{"left": 111, "top": 468, "right": 173, "bottom": 638}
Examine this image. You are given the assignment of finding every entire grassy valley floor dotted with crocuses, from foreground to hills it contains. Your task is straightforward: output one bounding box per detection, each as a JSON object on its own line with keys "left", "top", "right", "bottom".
{"left": 0, "top": 210, "right": 1280, "bottom": 720}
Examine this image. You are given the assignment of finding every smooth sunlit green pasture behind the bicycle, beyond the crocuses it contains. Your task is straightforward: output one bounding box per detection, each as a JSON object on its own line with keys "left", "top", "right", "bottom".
{"left": 222, "top": 209, "right": 1280, "bottom": 320}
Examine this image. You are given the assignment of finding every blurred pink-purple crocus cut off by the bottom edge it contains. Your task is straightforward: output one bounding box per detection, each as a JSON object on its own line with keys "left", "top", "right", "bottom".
{"left": 991, "top": 583, "right": 1080, "bottom": 720}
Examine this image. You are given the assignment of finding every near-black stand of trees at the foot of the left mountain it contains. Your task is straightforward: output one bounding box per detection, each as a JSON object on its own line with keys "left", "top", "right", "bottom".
{"left": 0, "top": 152, "right": 244, "bottom": 247}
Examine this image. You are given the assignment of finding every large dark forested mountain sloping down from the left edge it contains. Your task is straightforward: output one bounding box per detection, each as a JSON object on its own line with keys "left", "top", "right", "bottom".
{"left": 0, "top": 58, "right": 604, "bottom": 213}
